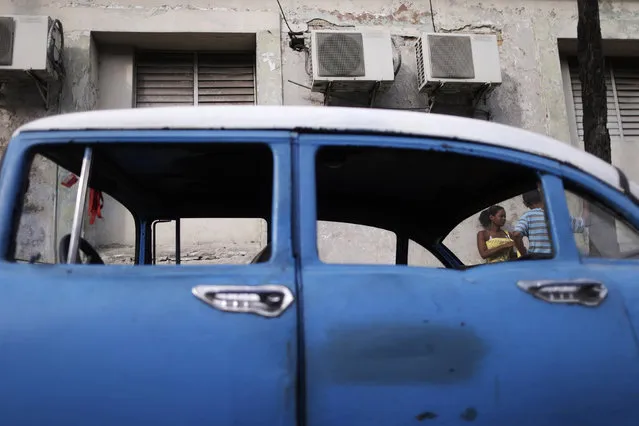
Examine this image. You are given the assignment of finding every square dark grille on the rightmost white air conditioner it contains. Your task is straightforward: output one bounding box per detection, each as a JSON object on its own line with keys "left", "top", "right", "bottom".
{"left": 428, "top": 35, "right": 475, "bottom": 79}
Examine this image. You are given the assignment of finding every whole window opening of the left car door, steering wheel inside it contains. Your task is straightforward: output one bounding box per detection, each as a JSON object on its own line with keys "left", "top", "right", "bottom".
{"left": 13, "top": 142, "right": 274, "bottom": 265}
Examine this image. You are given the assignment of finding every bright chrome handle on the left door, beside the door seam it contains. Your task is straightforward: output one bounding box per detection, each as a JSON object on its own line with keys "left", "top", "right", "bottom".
{"left": 192, "top": 285, "right": 294, "bottom": 318}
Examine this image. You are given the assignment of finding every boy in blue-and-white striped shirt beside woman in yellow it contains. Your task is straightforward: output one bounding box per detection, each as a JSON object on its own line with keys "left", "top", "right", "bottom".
{"left": 512, "top": 190, "right": 586, "bottom": 256}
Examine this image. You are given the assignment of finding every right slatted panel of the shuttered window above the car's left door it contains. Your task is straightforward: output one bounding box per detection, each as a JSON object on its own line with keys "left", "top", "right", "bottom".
{"left": 197, "top": 53, "right": 255, "bottom": 105}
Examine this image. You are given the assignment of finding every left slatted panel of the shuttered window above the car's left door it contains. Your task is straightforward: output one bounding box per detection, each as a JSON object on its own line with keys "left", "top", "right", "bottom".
{"left": 135, "top": 52, "right": 195, "bottom": 108}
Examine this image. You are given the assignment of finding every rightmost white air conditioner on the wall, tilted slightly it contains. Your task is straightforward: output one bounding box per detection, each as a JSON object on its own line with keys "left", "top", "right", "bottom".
{"left": 416, "top": 33, "right": 501, "bottom": 94}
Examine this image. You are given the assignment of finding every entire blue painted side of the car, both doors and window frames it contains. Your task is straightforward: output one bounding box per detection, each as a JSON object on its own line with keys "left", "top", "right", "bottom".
{"left": 0, "top": 130, "right": 639, "bottom": 426}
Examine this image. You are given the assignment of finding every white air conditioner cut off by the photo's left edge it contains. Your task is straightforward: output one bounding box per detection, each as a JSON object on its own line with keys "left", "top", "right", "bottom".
{"left": 0, "top": 15, "right": 64, "bottom": 81}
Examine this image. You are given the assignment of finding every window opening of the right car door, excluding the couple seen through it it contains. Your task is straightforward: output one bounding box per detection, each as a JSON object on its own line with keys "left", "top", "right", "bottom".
{"left": 316, "top": 146, "right": 546, "bottom": 267}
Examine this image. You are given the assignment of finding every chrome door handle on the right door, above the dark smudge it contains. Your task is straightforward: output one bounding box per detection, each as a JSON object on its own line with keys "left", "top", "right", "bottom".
{"left": 517, "top": 279, "right": 608, "bottom": 306}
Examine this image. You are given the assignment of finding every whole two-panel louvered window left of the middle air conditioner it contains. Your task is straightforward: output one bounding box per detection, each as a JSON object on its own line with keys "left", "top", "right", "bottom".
{"left": 135, "top": 52, "right": 255, "bottom": 108}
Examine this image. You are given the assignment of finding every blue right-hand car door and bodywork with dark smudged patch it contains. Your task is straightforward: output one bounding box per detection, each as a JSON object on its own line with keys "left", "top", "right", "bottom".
{"left": 298, "top": 135, "right": 639, "bottom": 426}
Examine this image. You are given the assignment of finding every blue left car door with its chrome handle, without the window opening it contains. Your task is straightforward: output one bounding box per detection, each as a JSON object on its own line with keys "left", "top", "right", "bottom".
{"left": 0, "top": 131, "right": 297, "bottom": 426}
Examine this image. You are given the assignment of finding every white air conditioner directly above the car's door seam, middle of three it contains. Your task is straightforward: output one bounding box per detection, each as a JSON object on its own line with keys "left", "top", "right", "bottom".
{"left": 310, "top": 30, "right": 395, "bottom": 92}
